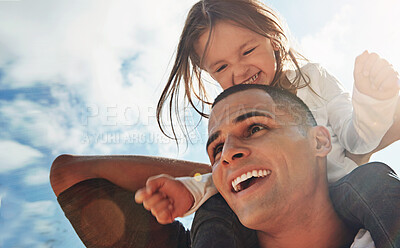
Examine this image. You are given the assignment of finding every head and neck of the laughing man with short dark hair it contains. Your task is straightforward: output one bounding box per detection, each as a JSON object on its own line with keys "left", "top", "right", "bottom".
{"left": 202, "top": 85, "right": 360, "bottom": 248}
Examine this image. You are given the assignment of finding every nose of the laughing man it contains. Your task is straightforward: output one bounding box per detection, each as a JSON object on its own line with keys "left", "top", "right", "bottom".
{"left": 222, "top": 136, "right": 250, "bottom": 165}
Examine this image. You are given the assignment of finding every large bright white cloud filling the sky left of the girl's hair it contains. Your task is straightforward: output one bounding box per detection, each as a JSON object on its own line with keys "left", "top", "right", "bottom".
{"left": 0, "top": 0, "right": 200, "bottom": 159}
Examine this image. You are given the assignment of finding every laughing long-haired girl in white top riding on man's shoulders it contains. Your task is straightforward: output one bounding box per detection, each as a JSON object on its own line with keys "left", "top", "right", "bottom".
{"left": 136, "top": 0, "right": 400, "bottom": 248}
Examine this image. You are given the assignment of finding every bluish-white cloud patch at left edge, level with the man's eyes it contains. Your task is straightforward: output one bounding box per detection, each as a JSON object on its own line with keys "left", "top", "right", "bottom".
{"left": 0, "top": 93, "right": 85, "bottom": 155}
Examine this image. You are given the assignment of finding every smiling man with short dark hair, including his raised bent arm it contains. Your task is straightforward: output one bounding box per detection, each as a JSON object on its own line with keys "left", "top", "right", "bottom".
{"left": 51, "top": 85, "right": 394, "bottom": 247}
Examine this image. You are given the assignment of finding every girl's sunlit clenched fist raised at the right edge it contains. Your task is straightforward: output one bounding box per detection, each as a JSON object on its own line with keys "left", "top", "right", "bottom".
{"left": 354, "top": 51, "right": 400, "bottom": 100}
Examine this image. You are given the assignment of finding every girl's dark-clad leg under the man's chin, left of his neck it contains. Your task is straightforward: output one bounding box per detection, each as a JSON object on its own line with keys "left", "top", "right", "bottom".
{"left": 191, "top": 194, "right": 258, "bottom": 248}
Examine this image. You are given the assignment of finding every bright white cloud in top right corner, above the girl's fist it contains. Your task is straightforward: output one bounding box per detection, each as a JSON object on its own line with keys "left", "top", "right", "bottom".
{"left": 300, "top": 0, "right": 400, "bottom": 90}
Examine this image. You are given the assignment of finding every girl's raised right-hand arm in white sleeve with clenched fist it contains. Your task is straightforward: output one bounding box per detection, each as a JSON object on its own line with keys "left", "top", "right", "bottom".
{"left": 314, "top": 54, "right": 399, "bottom": 154}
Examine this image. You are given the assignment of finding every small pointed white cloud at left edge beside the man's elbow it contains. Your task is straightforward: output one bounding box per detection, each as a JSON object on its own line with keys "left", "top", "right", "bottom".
{"left": 0, "top": 140, "right": 43, "bottom": 173}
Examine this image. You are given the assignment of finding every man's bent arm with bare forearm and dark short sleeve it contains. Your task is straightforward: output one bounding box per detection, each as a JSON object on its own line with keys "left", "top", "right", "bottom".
{"left": 50, "top": 155, "right": 210, "bottom": 248}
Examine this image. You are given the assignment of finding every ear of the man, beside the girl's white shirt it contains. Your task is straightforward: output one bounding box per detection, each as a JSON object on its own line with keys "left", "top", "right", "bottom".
{"left": 310, "top": 126, "right": 332, "bottom": 157}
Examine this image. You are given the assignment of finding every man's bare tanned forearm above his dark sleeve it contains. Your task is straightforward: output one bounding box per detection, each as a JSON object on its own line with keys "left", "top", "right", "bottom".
{"left": 50, "top": 155, "right": 211, "bottom": 196}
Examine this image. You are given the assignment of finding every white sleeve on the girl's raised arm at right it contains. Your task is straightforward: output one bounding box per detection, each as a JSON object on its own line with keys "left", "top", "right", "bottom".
{"left": 311, "top": 63, "right": 398, "bottom": 154}
